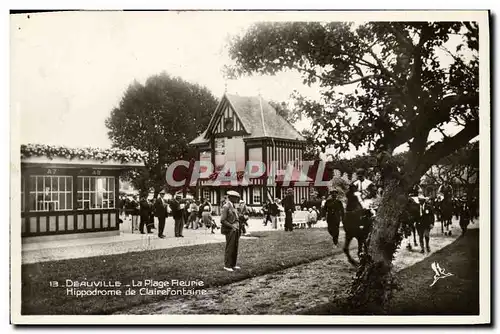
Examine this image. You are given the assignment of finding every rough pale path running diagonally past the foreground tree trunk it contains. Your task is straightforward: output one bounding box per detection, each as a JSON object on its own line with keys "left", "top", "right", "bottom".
{"left": 117, "top": 223, "right": 477, "bottom": 314}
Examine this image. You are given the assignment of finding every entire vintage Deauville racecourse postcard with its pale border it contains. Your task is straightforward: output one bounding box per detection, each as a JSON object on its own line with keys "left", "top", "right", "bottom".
{"left": 10, "top": 11, "right": 491, "bottom": 325}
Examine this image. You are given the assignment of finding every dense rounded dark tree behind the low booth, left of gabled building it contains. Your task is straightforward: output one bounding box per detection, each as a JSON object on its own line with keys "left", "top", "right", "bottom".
{"left": 106, "top": 73, "right": 217, "bottom": 191}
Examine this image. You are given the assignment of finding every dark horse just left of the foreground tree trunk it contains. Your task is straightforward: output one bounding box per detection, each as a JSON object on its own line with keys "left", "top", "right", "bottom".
{"left": 342, "top": 186, "right": 373, "bottom": 265}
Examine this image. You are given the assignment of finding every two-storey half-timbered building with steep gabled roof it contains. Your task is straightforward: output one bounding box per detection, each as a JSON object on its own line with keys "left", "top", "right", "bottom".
{"left": 190, "top": 93, "right": 312, "bottom": 213}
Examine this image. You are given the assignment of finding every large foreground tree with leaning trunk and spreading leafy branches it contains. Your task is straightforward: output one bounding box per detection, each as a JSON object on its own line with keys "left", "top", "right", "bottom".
{"left": 230, "top": 22, "right": 479, "bottom": 312}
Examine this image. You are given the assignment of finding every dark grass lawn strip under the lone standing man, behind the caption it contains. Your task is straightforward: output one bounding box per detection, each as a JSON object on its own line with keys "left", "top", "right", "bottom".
{"left": 21, "top": 229, "right": 344, "bottom": 315}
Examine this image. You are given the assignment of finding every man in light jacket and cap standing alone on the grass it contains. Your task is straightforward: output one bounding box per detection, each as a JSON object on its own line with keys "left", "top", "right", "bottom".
{"left": 220, "top": 190, "right": 241, "bottom": 271}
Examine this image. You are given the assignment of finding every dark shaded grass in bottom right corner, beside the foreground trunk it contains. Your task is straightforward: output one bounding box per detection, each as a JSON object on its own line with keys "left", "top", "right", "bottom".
{"left": 305, "top": 229, "right": 479, "bottom": 315}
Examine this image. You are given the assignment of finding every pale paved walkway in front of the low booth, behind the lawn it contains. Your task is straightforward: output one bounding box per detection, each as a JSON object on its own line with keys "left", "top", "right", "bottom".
{"left": 22, "top": 218, "right": 288, "bottom": 264}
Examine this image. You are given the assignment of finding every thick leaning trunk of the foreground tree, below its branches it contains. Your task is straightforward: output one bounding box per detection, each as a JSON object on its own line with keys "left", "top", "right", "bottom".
{"left": 349, "top": 180, "right": 409, "bottom": 314}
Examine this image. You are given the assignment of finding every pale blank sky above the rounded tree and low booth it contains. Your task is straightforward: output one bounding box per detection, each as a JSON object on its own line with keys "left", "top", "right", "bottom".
{"left": 11, "top": 11, "right": 476, "bottom": 160}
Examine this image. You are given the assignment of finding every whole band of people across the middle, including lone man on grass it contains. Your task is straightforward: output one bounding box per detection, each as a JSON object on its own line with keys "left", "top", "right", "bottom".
{"left": 119, "top": 170, "right": 478, "bottom": 271}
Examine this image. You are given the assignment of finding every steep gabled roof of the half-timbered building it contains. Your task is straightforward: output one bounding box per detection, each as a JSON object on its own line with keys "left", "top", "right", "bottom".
{"left": 190, "top": 93, "right": 305, "bottom": 145}
